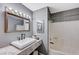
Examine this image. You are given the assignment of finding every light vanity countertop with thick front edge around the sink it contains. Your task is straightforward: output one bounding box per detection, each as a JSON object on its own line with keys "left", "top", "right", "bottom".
{"left": 0, "top": 40, "right": 42, "bottom": 55}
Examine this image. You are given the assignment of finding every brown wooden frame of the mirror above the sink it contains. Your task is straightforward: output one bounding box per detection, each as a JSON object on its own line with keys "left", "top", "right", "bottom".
{"left": 4, "top": 7, "right": 30, "bottom": 33}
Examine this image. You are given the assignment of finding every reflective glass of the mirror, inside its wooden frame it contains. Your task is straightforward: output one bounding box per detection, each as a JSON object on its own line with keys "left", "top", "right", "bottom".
{"left": 6, "top": 14, "right": 30, "bottom": 32}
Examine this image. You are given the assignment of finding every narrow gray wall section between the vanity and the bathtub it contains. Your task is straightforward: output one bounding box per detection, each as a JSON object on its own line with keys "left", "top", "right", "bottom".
{"left": 33, "top": 7, "right": 49, "bottom": 54}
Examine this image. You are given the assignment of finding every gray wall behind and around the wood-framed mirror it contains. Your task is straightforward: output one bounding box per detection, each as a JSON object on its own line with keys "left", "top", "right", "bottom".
{"left": 0, "top": 3, "right": 33, "bottom": 47}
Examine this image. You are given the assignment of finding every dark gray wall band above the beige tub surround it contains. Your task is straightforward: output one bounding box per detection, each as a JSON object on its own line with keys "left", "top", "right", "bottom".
{"left": 51, "top": 8, "right": 79, "bottom": 22}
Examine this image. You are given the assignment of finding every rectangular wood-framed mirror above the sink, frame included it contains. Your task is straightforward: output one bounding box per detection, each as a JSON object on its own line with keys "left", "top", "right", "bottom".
{"left": 4, "top": 7, "right": 30, "bottom": 33}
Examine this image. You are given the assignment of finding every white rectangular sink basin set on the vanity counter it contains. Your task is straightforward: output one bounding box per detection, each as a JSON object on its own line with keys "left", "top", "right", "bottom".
{"left": 11, "top": 38, "right": 36, "bottom": 49}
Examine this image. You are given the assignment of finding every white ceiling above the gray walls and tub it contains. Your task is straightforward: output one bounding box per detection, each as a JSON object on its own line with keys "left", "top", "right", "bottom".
{"left": 23, "top": 3, "right": 79, "bottom": 13}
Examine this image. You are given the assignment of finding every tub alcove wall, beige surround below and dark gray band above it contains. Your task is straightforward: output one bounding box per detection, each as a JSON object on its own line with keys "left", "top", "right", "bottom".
{"left": 49, "top": 8, "right": 79, "bottom": 54}
